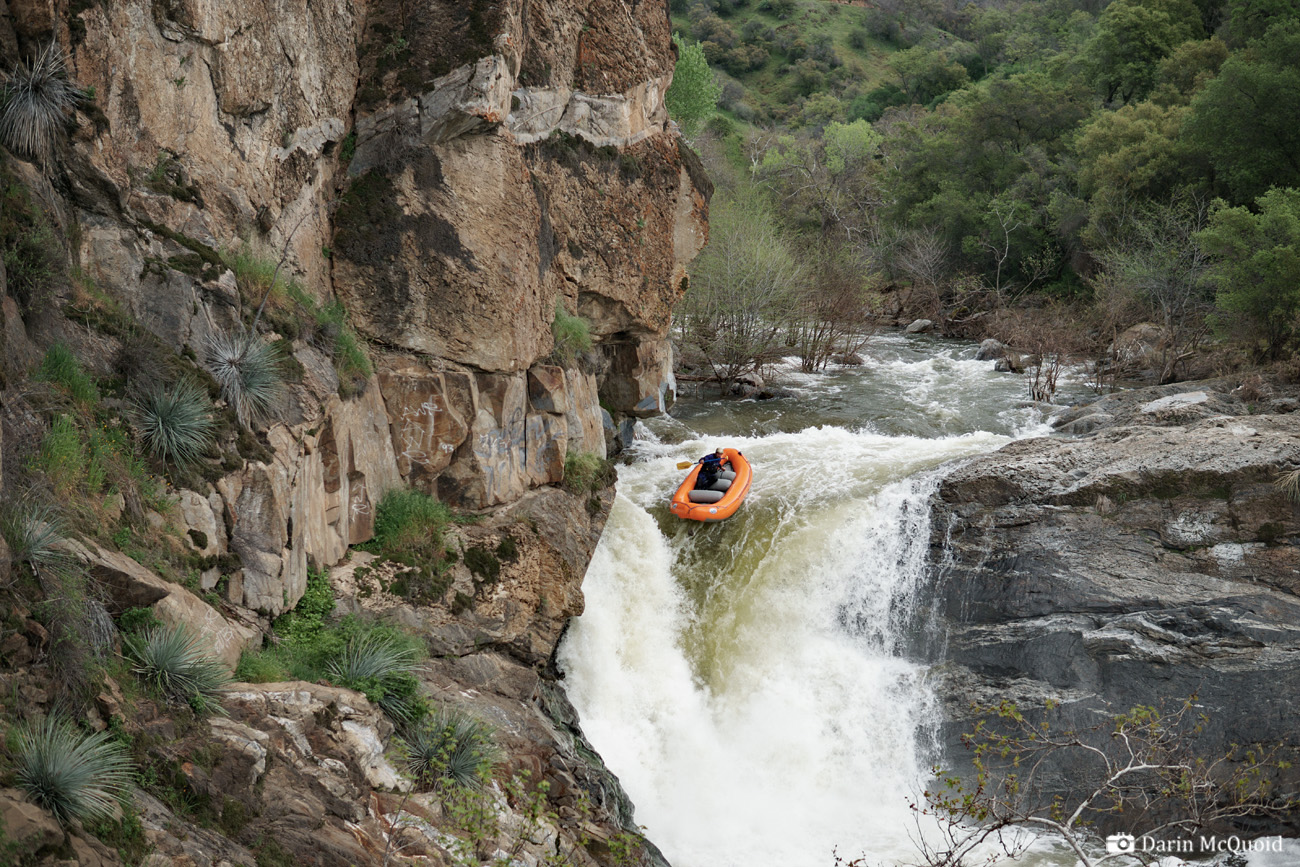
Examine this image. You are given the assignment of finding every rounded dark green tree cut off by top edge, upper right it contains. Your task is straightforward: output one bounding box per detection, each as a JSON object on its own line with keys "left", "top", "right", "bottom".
{"left": 1087, "top": 0, "right": 1204, "bottom": 103}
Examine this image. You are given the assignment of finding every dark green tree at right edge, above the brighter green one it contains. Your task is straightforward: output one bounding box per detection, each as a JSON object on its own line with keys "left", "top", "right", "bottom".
{"left": 1184, "top": 21, "right": 1300, "bottom": 204}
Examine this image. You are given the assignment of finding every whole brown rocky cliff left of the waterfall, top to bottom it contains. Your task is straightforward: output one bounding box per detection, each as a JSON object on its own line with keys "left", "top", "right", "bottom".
{"left": 0, "top": 0, "right": 711, "bottom": 863}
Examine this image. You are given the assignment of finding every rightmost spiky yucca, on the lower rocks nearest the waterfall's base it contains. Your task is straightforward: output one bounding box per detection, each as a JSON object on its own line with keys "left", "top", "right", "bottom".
{"left": 402, "top": 707, "right": 501, "bottom": 789}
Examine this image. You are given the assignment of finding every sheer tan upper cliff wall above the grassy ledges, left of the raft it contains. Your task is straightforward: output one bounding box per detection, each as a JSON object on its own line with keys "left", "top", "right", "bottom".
{"left": 35, "top": 0, "right": 710, "bottom": 614}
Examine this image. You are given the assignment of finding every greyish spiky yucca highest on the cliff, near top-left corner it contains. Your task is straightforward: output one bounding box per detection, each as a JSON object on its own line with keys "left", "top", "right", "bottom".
{"left": 0, "top": 42, "right": 82, "bottom": 161}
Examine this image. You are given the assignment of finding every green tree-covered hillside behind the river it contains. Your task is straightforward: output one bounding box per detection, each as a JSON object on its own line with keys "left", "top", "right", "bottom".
{"left": 673, "top": 0, "right": 1300, "bottom": 381}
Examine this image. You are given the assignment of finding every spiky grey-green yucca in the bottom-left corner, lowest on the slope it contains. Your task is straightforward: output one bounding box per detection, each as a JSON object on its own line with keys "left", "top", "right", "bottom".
{"left": 14, "top": 716, "right": 133, "bottom": 824}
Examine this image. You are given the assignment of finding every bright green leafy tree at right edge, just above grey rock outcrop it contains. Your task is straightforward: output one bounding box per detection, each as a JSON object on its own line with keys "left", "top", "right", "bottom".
{"left": 1196, "top": 190, "right": 1300, "bottom": 357}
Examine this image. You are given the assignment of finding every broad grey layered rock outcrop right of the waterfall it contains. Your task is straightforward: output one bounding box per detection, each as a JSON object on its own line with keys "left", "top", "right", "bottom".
{"left": 932, "top": 383, "right": 1300, "bottom": 832}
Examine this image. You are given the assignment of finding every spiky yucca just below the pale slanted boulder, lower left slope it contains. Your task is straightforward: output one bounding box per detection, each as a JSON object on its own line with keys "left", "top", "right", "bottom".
{"left": 122, "top": 627, "right": 230, "bottom": 716}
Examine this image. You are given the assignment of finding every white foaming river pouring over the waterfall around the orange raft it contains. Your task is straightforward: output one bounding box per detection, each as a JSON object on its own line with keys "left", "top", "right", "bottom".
{"left": 559, "top": 334, "right": 1086, "bottom": 867}
